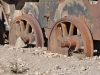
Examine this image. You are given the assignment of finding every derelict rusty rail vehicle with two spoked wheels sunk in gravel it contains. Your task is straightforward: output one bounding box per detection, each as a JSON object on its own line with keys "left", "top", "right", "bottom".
{"left": 0, "top": 0, "right": 100, "bottom": 57}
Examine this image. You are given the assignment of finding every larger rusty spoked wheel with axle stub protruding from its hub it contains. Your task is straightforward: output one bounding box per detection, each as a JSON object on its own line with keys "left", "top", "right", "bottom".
{"left": 48, "top": 16, "right": 93, "bottom": 57}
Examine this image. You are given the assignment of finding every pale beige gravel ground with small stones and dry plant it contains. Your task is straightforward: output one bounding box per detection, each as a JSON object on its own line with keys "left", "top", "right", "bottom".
{"left": 0, "top": 45, "right": 100, "bottom": 75}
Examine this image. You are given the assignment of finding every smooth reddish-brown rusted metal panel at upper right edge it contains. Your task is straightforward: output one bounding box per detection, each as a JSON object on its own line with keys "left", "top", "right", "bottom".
{"left": 84, "top": 0, "right": 100, "bottom": 40}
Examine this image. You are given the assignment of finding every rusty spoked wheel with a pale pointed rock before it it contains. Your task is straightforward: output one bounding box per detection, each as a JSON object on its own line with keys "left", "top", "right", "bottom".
{"left": 9, "top": 15, "right": 44, "bottom": 47}
